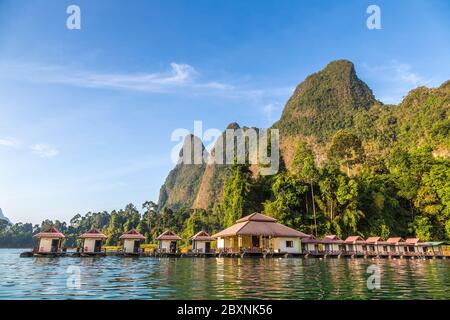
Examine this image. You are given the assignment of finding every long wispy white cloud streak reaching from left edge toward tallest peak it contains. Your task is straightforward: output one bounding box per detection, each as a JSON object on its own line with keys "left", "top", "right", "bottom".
{"left": 0, "top": 61, "right": 294, "bottom": 100}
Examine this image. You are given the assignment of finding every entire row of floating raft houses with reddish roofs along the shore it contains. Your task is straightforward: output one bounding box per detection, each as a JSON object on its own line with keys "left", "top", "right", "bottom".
{"left": 17, "top": 213, "right": 450, "bottom": 259}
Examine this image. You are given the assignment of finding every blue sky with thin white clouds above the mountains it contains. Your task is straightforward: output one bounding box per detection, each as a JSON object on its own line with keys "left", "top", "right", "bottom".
{"left": 0, "top": 0, "right": 450, "bottom": 223}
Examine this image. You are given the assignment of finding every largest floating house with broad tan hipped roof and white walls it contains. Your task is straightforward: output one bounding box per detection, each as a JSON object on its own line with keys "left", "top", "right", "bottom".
{"left": 212, "top": 213, "right": 310, "bottom": 255}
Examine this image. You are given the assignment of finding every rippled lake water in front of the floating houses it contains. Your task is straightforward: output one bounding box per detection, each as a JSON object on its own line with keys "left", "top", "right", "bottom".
{"left": 0, "top": 249, "right": 450, "bottom": 299}
